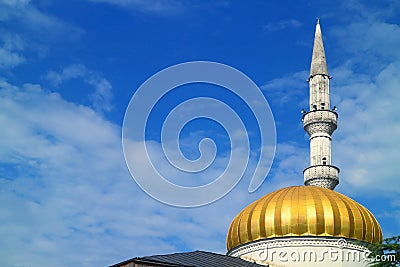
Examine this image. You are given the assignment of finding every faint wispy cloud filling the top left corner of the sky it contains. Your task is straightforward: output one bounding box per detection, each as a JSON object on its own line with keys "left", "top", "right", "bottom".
{"left": 0, "top": 0, "right": 83, "bottom": 60}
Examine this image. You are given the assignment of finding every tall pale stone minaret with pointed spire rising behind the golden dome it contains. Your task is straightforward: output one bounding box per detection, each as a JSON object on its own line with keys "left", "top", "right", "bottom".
{"left": 302, "top": 19, "right": 339, "bottom": 190}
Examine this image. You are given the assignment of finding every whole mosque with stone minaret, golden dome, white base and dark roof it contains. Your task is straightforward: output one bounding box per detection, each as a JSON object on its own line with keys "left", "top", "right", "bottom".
{"left": 113, "top": 20, "right": 382, "bottom": 267}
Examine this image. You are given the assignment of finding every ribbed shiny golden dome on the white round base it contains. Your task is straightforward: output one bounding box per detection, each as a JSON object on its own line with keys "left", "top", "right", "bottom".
{"left": 226, "top": 186, "right": 382, "bottom": 251}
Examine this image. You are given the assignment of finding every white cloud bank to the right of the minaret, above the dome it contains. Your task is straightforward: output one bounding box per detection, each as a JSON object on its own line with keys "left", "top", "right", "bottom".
{"left": 334, "top": 62, "right": 400, "bottom": 195}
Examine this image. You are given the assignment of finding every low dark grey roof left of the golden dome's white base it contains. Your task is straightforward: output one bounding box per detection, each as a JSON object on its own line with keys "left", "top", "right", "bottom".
{"left": 110, "top": 250, "right": 265, "bottom": 267}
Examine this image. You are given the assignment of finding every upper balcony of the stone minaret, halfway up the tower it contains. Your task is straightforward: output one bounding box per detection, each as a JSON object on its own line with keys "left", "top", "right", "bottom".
{"left": 302, "top": 109, "right": 338, "bottom": 136}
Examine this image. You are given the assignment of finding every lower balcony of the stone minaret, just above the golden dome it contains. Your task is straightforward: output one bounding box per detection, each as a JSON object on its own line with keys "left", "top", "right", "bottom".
{"left": 303, "top": 165, "right": 340, "bottom": 189}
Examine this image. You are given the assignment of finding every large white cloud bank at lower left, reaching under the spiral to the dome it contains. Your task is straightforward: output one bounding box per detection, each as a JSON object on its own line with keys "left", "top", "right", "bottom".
{"left": 0, "top": 79, "right": 278, "bottom": 266}
